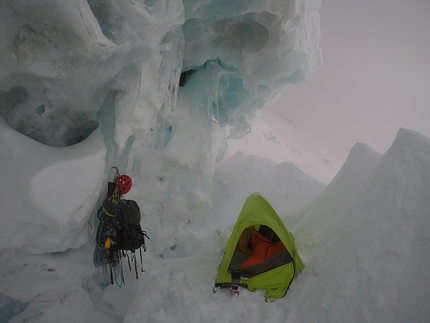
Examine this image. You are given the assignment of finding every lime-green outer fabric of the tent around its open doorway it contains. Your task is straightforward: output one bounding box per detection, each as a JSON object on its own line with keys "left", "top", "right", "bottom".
{"left": 215, "top": 193, "right": 304, "bottom": 299}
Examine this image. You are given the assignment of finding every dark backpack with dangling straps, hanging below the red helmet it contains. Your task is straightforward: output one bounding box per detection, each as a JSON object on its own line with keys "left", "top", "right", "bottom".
{"left": 93, "top": 199, "right": 149, "bottom": 285}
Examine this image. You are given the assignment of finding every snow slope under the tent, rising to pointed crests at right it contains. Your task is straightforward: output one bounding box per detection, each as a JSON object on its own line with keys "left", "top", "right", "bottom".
{"left": 121, "top": 129, "right": 430, "bottom": 322}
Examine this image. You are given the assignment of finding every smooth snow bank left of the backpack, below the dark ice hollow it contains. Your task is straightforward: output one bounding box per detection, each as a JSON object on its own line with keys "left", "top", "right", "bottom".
{"left": 0, "top": 118, "right": 106, "bottom": 253}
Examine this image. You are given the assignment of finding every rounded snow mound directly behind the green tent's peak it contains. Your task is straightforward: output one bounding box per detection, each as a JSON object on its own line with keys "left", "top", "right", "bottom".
{"left": 208, "top": 151, "right": 325, "bottom": 228}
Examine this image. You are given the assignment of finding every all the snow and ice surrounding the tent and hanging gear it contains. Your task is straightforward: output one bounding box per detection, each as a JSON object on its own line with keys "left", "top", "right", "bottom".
{"left": 0, "top": 0, "right": 430, "bottom": 323}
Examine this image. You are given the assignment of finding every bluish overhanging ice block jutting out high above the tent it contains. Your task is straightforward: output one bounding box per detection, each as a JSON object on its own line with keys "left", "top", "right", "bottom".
{"left": 182, "top": 0, "right": 321, "bottom": 137}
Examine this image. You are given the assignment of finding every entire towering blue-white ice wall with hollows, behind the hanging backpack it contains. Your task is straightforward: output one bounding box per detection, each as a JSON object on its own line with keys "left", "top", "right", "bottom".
{"left": 0, "top": 0, "right": 321, "bottom": 253}
